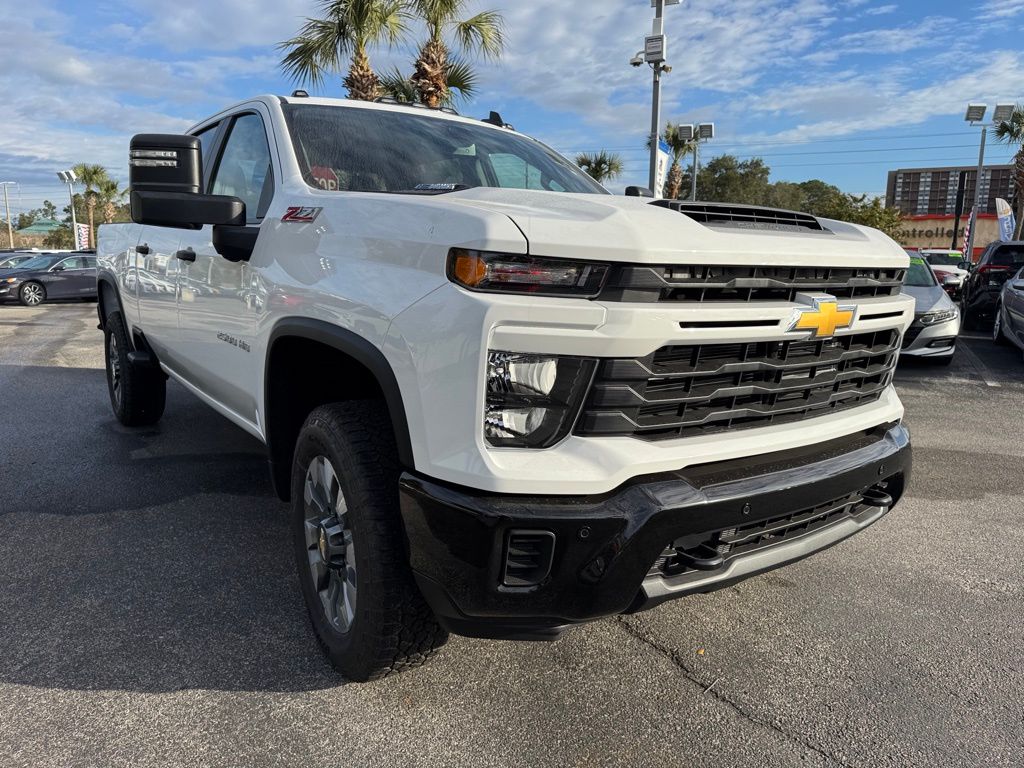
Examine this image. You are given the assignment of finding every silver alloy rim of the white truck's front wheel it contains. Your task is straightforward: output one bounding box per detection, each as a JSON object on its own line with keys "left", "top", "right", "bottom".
{"left": 303, "top": 456, "right": 356, "bottom": 634}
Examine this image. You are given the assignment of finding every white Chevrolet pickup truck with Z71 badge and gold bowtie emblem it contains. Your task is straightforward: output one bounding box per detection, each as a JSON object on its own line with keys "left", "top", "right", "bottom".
{"left": 98, "top": 94, "right": 913, "bottom": 680}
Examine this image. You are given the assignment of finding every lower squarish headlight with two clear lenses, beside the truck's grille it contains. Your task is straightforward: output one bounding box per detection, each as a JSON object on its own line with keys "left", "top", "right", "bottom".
{"left": 483, "top": 351, "right": 597, "bottom": 449}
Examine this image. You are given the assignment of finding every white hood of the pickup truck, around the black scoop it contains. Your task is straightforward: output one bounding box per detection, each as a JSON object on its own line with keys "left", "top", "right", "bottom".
{"left": 444, "top": 187, "right": 907, "bottom": 266}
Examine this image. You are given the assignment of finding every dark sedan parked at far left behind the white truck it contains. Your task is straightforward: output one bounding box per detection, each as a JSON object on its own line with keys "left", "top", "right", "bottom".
{"left": 0, "top": 253, "right": 96, "bottom": 306}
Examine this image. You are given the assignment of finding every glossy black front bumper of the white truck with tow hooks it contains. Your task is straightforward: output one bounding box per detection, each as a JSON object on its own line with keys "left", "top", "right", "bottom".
{"left": 400, "top": 424, "right": 911, "bottom": 639}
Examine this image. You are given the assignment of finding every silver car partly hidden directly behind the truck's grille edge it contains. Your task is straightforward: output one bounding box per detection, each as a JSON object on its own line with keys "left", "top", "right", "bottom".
{"left": 900, "top": 253, "right": 959, "bottom": 366}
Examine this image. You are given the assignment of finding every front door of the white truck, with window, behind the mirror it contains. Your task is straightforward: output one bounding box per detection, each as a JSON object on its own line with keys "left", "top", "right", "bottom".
{"left": 178, "top": 110, "right": 274, "bottom": 425}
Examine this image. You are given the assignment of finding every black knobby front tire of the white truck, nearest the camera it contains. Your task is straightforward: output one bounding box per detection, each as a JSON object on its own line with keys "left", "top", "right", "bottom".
{"left": 291, "top": 400, "right": 447, "bottom": 682}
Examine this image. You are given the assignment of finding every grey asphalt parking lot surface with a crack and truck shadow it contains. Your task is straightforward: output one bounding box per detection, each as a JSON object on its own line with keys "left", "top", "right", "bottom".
{"left": 0, "top": 304, "right": 1024, "bottom": 768}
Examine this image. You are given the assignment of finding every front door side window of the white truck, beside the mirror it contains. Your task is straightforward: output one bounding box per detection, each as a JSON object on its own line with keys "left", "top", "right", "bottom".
{"left": 211, "top": 114, "right": 273, "bottom": 221}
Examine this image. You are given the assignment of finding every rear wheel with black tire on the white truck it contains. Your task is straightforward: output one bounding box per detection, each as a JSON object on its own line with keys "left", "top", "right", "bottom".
{"left": 103, "top": 311, "right": 167, "bottom": 427}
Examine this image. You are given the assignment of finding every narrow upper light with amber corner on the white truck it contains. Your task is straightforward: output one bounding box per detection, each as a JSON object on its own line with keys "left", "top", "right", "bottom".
{"left": 447, "top": 248, "right": 608, "bottom": 298}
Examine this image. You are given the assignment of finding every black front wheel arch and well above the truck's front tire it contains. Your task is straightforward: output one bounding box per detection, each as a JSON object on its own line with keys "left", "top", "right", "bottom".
{"left": 263, "top": 317, "right": 415, "bottom": 501}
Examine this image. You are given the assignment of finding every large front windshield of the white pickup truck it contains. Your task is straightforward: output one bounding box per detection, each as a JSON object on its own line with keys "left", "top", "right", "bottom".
{"left": 285, "top": 104, "right": 608, "bottom": 195}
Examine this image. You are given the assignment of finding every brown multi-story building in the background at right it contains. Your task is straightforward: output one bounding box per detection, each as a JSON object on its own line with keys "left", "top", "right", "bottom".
{"left": 886, "top": 165, "right": 1014, "bottom": 216}
